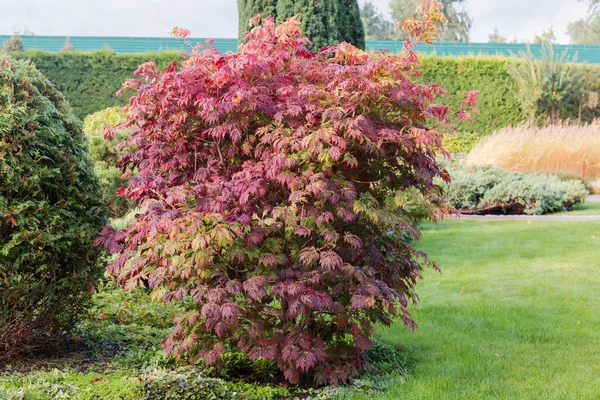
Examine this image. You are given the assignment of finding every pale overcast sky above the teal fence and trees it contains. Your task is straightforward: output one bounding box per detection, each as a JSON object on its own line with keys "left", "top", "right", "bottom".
{"left": 0, "top": 0, "right": 587, "bottom": 43}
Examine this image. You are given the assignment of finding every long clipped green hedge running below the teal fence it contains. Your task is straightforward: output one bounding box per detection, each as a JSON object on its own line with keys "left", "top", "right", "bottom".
{"left": 15, "top": 50, "right": 600, "bottom": 147}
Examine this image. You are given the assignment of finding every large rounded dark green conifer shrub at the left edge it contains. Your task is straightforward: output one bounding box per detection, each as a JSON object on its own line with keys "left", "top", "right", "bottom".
{"left": 0, "top": 55, "right": 106, "bottom": 358}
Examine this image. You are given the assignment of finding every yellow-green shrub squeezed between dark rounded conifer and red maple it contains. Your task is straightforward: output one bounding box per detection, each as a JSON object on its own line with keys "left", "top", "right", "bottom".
{"left": 83, "top": 107, "right": 131, "bottom": 218}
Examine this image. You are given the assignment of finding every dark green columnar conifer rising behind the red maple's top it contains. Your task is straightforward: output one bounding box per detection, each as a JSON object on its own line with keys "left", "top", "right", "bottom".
{"left": 238, "top": 0, "right": 365, "bottom": 50}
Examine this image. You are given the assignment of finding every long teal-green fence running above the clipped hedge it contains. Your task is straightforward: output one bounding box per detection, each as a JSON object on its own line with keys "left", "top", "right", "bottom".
{"left": 0, "top": 35, "right": 600, "bottom": 64}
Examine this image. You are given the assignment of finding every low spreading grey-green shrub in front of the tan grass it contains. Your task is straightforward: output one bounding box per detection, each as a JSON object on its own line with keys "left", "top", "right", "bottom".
{"left": 446, "top": 165, "right": 588, "bottom": 215}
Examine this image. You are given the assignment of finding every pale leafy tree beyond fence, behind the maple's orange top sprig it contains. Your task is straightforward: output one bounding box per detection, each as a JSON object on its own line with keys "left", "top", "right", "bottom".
{"left": 390, "top": 0, "right": 473, "bottom": 42}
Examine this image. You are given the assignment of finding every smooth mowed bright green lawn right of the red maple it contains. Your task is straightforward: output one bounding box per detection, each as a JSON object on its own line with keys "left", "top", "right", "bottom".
{"left": 355, "top": 221, "right": 600, "bottom": 400}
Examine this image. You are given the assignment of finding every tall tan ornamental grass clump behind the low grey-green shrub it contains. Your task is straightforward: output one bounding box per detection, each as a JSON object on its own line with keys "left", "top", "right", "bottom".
{"left": 466, "top": 121, "right": 600, "bottom": 181}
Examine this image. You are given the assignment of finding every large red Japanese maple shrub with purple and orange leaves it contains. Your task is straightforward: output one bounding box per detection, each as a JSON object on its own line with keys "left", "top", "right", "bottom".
{"left": 98, "top": 1, "right": 474, "bottom": 384}
